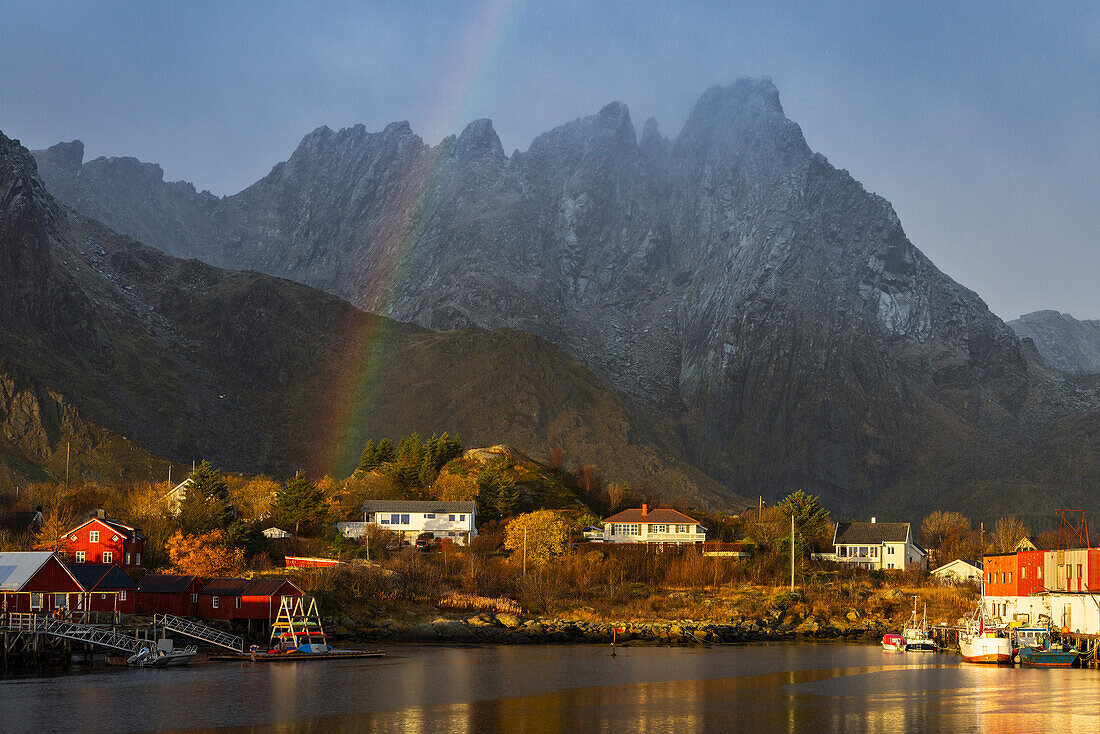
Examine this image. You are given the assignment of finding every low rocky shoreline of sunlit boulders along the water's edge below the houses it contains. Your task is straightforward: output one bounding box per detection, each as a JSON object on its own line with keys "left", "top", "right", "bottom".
{"left": 316, "top": 610, "right": 893, "bottom": 645}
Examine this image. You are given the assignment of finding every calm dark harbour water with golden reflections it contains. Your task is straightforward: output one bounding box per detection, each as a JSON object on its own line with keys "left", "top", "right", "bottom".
{"left": 0, "top": 643, "right": 1100, "bottom": 734}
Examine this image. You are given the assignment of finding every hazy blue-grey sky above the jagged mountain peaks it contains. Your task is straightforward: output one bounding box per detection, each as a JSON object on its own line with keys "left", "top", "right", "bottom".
{"left": 0, "top": 0, "right": 1100, "bottom": 319}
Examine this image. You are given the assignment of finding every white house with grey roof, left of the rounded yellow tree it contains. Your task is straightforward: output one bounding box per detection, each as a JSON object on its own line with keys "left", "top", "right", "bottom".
{"left": 349, "top": 500, "right": 477, "bottom": 545}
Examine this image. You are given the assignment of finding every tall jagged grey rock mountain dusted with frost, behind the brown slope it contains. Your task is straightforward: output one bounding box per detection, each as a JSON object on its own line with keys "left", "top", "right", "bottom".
{"left": 27, "top": 79, "right": 1100, "bottom": 515}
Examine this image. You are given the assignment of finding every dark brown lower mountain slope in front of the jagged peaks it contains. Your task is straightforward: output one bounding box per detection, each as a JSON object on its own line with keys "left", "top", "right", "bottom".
{"left": 8, "top": 133, "right": 728, "bottom": 505}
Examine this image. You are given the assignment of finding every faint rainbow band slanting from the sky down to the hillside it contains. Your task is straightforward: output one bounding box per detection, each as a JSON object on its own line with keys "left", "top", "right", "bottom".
{"left": 311, "top": 0, "right": 521, "bottom": 476}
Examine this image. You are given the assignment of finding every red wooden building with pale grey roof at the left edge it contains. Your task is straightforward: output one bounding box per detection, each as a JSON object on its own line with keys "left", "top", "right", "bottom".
{"left": 0, "top": 551, "right": 84, "bottom": 613}
